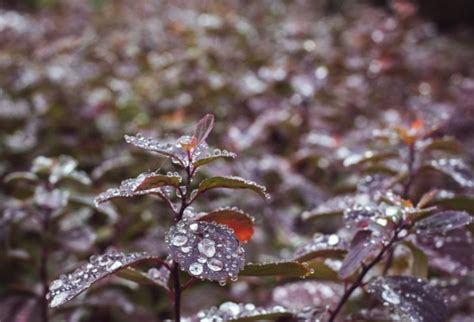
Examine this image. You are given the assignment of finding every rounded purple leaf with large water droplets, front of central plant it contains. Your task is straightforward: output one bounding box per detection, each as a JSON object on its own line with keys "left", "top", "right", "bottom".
{"left": 166, "top": 220, "right": 245, "bottom": 284}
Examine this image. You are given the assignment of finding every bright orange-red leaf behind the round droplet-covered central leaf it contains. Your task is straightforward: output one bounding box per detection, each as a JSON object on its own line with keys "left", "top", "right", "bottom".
{"left": 196, "top": 207, "right": 254, "bottom": 243}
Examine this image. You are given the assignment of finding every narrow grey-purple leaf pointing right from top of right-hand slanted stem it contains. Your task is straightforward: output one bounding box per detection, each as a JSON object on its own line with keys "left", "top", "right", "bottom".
{"left": 415, "top": 210, "right": 472, "bottom": 234}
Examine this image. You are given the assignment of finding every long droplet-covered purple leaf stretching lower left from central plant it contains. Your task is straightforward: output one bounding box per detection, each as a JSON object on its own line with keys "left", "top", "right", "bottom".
{"left": 47, "top": 251, "right": 151, "bottom": 308}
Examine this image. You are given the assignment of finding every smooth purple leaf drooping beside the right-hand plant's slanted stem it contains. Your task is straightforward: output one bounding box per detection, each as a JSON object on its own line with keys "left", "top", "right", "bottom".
{"left": 339, "top": 230, "right": 381, "bottom": 279}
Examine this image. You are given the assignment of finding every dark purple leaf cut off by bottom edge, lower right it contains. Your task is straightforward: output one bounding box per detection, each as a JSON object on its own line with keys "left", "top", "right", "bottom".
{"left": 368, "top": 276, "right": 448, "bottom": 322}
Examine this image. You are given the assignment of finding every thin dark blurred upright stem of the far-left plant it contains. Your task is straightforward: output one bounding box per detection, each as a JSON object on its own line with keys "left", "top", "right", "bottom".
{"left": 39, "top": 211, "right": 49, "bottom": 322}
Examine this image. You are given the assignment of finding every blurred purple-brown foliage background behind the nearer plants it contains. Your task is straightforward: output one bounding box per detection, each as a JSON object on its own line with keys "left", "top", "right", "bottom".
{"left": 0, "top": 0, "right": 474, "bottom": 321}
